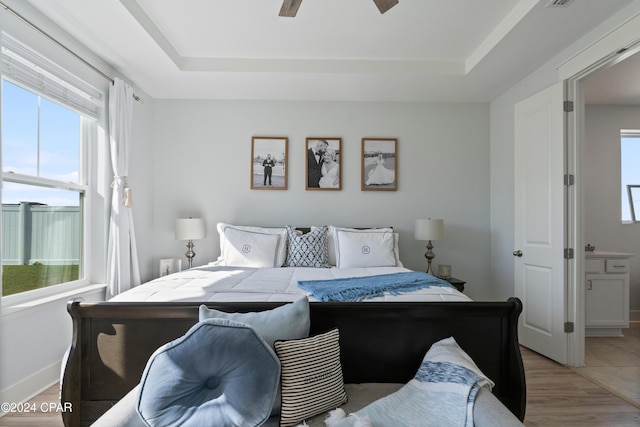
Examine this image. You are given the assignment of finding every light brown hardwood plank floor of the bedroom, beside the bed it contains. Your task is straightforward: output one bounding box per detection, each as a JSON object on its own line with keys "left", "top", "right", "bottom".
{"left": 0, "top": 342, "right": 640, "bottom": 427}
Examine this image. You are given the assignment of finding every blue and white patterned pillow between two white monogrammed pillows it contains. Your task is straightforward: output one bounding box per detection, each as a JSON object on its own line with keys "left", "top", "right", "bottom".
{"left": 285, "top": 225, "right": 329, "bottom": 268}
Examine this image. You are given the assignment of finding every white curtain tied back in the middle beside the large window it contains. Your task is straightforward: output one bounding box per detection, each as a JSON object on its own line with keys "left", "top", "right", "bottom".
{"left": 107, "top": 78, "right": 140, "bottom": 298}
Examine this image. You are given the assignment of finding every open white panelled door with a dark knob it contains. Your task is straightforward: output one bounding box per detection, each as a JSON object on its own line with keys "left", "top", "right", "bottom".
{"left": 513, "top": 83, "right": 568, "bottom": 364}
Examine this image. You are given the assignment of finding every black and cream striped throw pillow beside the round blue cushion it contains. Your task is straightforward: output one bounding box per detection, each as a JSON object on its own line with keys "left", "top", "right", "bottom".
{"left": 275, "top": 329, "right": 347, "bottom": 427}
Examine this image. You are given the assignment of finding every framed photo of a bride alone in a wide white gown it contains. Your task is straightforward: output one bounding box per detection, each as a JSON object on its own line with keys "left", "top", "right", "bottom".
{"left": 360, "top": 138, "right": 398, "bottom": 191}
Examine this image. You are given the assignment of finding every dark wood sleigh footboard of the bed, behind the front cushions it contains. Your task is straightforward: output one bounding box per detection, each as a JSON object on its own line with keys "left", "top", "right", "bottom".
{"left": 61, "top": 298, "right": 526, "bottom": 427}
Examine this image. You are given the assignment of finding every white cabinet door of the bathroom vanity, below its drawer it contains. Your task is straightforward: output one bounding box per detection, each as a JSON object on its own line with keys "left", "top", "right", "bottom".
{"left": 585, "top": 274, "right": 629, "bottom": 328}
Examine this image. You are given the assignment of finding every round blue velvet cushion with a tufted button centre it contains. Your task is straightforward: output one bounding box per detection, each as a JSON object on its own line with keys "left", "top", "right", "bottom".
{"left": 136, "top": 319, "right": 280, "bottom": 427}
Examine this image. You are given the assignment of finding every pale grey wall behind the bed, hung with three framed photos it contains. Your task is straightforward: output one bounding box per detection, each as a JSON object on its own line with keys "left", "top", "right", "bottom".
{"left": 149, "top": 100, "right": 495, "bottom": 299}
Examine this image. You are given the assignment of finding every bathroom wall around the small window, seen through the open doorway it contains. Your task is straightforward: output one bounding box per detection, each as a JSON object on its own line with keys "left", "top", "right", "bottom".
{"left": 583, "top": 105, "right": 640, "bottom": 311}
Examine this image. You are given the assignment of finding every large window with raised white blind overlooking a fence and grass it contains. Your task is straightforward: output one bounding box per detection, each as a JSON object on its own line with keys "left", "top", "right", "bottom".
{"left": 0, "top": 32, "right": 104, "bottom": 301}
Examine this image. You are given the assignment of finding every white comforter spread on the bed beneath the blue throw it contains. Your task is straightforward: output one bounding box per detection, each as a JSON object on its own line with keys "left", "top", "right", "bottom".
{"left": 110, "top": 265, "right": 471, "bottom": 301}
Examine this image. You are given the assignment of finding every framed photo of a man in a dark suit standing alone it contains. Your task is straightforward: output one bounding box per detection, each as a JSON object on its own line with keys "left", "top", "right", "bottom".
{"left": 251, "top": 136, "right": 289, "bottom": 190}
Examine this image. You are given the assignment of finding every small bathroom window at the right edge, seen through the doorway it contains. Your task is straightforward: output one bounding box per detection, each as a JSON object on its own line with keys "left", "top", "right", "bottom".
{"left": 620, "top": 129, "right": 640, "bottom": 223}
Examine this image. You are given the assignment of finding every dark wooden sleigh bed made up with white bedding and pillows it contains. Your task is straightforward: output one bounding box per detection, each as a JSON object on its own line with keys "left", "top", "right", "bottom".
{"left": 61, "top": 224, "right": 525, "bottom": 427}
